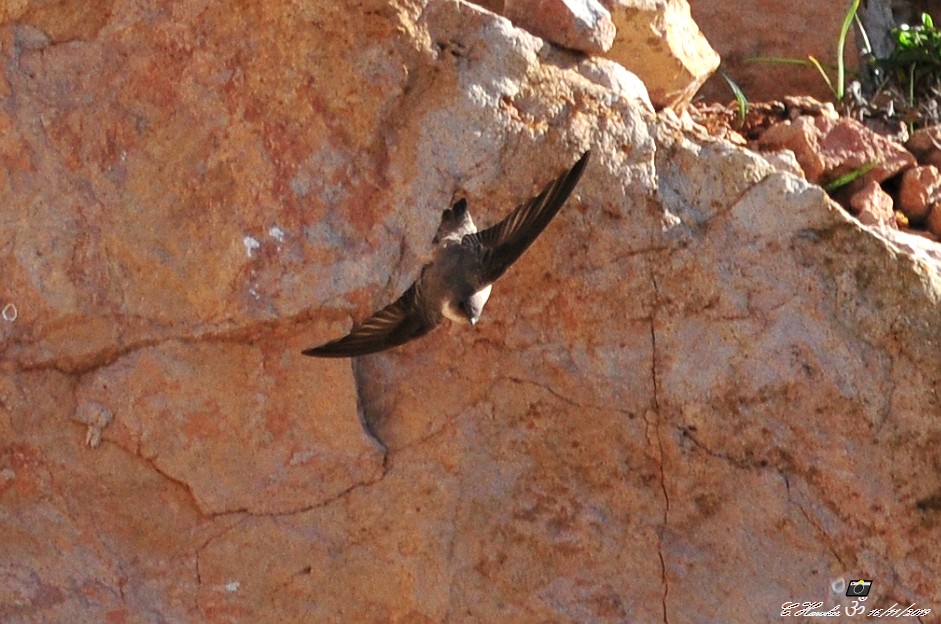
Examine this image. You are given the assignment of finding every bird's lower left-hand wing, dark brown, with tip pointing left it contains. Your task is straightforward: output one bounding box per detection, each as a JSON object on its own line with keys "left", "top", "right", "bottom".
{"left": 303, "top": 284, "right": 437, "bottom": 357}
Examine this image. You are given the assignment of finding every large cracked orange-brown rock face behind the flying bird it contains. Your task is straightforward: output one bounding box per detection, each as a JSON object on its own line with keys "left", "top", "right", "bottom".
{"left": 0, "top": 0, "right": 941, "bottom": 623}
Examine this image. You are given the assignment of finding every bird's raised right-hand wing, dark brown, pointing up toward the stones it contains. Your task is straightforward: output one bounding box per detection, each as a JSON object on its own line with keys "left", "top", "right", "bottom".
{"left": 474, "top": 150, "right": 591, "bottom": 283}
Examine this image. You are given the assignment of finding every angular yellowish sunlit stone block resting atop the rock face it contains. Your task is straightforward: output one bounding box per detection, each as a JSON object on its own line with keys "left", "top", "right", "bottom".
{"left": 602, "top": 0, "right": 719, "bottom": 108}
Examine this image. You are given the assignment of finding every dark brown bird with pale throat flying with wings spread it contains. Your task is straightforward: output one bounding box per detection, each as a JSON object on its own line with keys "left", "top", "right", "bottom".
{"left": 302, "top": 150, "right": 591, "bottom": 358}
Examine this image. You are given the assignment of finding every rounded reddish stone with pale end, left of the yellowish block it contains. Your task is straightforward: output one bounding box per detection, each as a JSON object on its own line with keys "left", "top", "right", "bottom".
{"left": 503, "top": 0, "right": 615, "bottom": 54}
